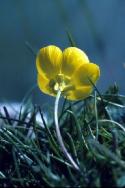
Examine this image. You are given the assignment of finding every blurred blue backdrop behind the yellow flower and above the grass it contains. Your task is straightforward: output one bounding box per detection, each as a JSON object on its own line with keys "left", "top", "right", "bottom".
{"left": 0, "top": 0, "right": 125, "bottom": 103}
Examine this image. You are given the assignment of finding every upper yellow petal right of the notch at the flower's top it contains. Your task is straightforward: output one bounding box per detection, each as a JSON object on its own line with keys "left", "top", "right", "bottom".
{"left": 61, "top": 47, "right": 89, "bottom": 77}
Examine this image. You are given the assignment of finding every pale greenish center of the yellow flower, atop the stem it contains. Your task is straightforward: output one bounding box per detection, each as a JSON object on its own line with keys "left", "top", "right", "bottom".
{"left": 49, "top": 74, "right": 74, "bottom": 94}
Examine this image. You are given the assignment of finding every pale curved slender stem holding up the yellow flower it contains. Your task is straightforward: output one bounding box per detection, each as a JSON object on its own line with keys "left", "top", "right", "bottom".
{"left": 54, "top": 90, "right": 80, "bottom": 170}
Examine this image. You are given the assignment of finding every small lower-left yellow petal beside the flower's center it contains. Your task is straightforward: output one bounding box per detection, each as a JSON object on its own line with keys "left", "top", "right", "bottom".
{"left": 37, "top": 74, "right": 54, "bottom": 96}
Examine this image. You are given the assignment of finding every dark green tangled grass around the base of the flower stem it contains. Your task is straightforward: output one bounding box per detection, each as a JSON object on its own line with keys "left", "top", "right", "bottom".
{"left": 0, "top": 86, "right": 125, "bottom": 187}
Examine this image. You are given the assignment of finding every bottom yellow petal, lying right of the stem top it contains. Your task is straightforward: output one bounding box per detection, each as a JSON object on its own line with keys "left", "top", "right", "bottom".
{"left": 66, "top": 86, "right": 92, "bottom": 100}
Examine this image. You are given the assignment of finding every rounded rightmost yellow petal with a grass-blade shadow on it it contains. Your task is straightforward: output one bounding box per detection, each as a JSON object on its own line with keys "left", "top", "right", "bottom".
{"left": 71, "top": 63, "right": 100, "bottom": 86}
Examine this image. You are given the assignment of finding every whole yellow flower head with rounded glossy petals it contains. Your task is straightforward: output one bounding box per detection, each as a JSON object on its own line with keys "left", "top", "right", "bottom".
{"left": 36, "top": 45, "right": 100, "bottom": 100}
